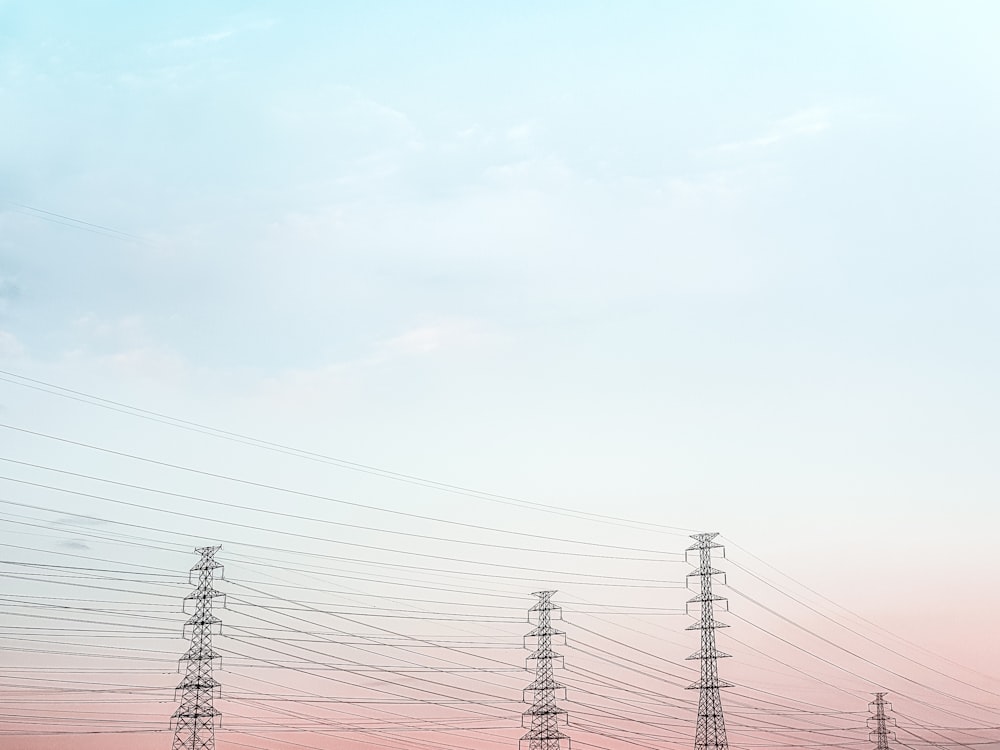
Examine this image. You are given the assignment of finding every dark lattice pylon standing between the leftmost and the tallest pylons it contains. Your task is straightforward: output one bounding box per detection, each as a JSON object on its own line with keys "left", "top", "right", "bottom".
{"left": 519, "top": 591, "right": 570, "bottom": 750}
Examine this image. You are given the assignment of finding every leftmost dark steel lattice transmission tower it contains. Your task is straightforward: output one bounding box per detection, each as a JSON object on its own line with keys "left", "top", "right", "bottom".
{"left": 171, "top": 547, "right": 224, "bottom": 750}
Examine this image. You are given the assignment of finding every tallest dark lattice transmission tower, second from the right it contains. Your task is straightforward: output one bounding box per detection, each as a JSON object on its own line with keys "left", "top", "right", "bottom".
{"left": 684, "top": 533, "right": 732, "bottom": 750}
